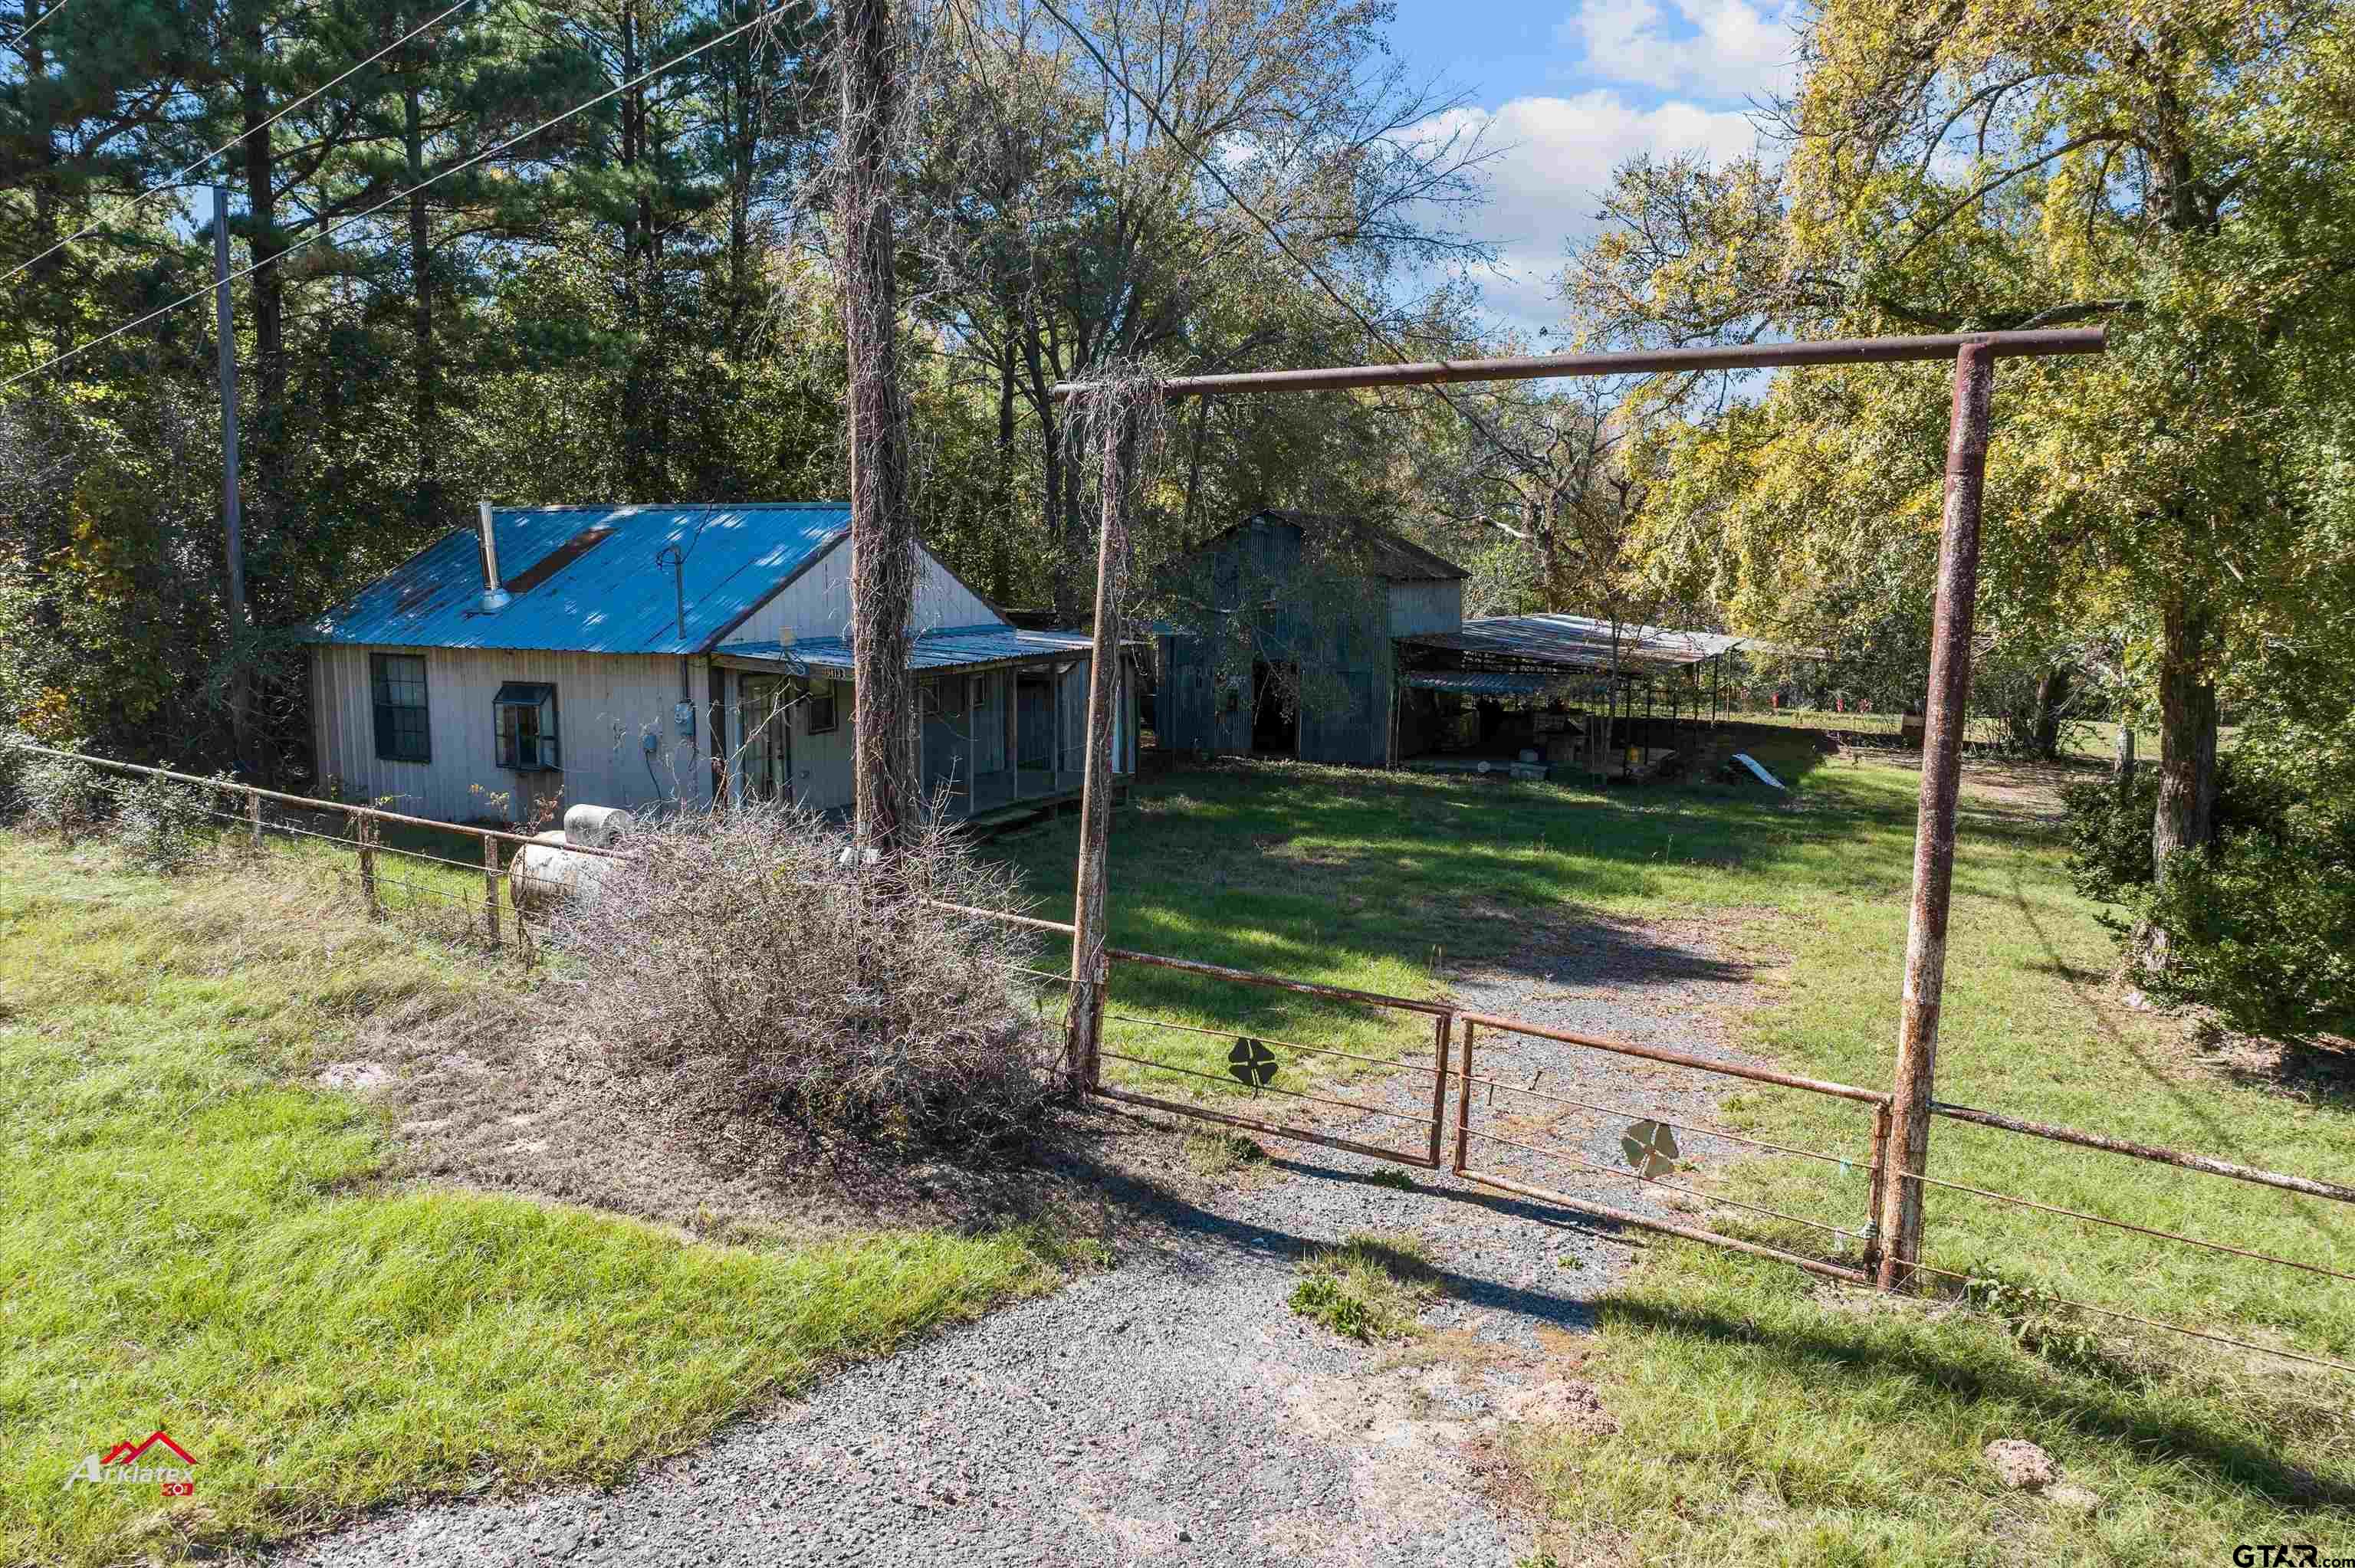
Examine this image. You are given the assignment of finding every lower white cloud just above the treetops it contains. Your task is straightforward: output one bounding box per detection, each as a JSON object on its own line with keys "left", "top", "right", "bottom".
{"left": 1417, "top": 87, "right": 1757, "bottom": 327}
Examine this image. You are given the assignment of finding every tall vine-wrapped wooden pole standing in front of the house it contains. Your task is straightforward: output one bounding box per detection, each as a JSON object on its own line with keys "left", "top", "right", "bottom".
{"left": 833, "top": 0, "right": 916, "bottom": 850}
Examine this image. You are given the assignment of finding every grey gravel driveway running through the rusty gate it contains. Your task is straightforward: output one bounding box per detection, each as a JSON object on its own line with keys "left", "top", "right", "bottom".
{"left": 283, "top": 923, "right": 1747, "bottom": 1568}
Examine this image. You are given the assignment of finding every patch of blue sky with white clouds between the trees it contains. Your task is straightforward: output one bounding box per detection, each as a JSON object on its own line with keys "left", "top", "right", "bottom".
{"left": 1389, "top": 0, "right": 1795, "bottom": 330}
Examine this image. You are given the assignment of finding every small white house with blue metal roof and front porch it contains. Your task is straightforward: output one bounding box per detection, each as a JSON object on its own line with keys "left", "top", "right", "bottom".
{"left": 306, "top": 501, "right": 1138, "bottom": 822}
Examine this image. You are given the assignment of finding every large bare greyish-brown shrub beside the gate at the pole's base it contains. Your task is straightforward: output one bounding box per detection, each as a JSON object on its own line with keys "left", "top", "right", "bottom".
{"left": 551, "top": 805, "right": 1055, "bottom": 1146}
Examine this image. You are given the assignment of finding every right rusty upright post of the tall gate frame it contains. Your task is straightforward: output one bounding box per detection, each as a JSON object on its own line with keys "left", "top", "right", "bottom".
{"left": 1879, "top": 344, "right": 1995, "bottom": 1290}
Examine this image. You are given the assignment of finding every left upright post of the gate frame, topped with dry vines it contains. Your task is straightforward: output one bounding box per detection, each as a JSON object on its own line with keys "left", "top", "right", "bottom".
{"left": 1073, "top": 419, "right": 1131, "bottom": 1095}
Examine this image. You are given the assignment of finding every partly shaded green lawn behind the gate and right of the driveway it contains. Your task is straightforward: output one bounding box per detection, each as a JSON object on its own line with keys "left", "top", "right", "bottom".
{"left": 1008, "top": 753, "right": 2355, "bottom": 1563}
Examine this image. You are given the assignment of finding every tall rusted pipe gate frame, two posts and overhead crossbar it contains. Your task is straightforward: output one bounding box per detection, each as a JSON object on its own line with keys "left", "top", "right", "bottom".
{"left": 1053, "top": 327, "right": 2107, "bottom": 1288}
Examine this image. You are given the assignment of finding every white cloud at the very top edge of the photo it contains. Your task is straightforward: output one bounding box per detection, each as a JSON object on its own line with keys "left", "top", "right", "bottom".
{"left": 1555, "top": 0, "right": 1799, "bottom": 103}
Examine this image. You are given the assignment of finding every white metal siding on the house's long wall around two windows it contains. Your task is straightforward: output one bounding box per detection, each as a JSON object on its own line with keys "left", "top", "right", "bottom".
{"left": 318, "top": 648, "right": 706, "bottom": 822}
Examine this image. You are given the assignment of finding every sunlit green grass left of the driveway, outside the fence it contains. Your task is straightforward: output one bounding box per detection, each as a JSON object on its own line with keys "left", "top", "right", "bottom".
{"left": 0, "top": 836, "right": 1062, "bottom": 1563}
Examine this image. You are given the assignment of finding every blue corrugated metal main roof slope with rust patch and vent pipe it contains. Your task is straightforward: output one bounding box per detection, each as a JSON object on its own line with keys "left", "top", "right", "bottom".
{"left": 308, "top": 501, "right": 850, "bottom": 654}
